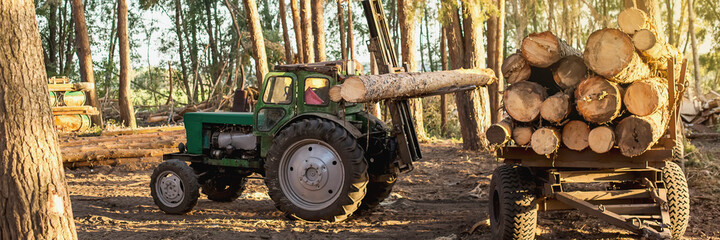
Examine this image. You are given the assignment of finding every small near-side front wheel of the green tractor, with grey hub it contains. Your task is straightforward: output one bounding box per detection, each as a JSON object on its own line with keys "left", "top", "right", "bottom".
{"left": 150, "top": 159, "right": 200, "bottom": 214}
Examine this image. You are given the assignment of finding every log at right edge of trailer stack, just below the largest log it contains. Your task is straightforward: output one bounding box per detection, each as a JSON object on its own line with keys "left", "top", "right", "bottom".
{"left": 623, "top": 78, "right": 668, "bottom": 117}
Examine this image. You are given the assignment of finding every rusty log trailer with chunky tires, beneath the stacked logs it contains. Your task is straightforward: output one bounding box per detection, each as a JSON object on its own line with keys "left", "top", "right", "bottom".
{"left": 489, "top": 61, "right": 690, "bottom": 239}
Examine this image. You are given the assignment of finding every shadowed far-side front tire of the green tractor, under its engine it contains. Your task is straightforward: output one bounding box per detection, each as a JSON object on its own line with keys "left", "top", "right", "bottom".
{"left": 202, "top": 175, "right": 247, "bottom": 202}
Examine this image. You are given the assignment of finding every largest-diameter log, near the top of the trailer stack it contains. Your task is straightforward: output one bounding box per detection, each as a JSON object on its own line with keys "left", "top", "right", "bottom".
{"left": 583, "top": 28, "right": 651, "bottom": 83}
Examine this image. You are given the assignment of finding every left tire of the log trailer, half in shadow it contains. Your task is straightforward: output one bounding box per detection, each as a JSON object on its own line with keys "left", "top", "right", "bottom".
{"left": 488, "top": 165, "right": 538, "bottom": 240}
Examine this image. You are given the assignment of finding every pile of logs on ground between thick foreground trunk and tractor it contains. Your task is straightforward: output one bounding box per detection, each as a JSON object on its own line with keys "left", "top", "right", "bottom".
{"left": 59, "top": 128, "right": 185, "bottom": 168}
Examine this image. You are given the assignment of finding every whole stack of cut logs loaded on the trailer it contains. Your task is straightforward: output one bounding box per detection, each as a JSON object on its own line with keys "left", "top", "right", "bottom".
{"left": 486, "top": 8, "right": 682, "bottom": 157}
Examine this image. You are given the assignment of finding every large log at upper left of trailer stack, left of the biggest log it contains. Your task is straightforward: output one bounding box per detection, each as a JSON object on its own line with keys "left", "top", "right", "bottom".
{"left": 521, "top": 31, "right": 580, "bottom": 68}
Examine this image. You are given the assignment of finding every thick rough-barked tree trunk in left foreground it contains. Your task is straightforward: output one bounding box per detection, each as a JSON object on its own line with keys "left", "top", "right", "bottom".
{"left": 0, "top": 0, "right": 77, "bottom": 239}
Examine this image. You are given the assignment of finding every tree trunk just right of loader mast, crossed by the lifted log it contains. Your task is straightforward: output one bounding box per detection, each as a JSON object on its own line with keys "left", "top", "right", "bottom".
{"left": 397, "top": 0, "right": 427, "bottom": 140}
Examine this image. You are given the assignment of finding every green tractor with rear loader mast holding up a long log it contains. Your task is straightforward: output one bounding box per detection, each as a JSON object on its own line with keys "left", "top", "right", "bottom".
{"left": 150, "top": 0, "right": 476, "bottom": 221}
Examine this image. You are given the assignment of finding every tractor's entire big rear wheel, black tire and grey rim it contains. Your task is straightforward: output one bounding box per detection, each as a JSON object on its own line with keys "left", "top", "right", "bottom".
{"left": 265, "top": 119, "right": 368, "bottom": 222}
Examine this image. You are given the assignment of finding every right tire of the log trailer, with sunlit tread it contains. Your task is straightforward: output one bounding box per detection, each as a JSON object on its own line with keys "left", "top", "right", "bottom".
{"left": 662, "top": 161, "right": 690, "bottom": 239}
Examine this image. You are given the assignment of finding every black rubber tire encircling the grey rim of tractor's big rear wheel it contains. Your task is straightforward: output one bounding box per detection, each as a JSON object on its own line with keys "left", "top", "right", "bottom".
{"left": 265, "top": 119, "right": 368, "bottom": 222}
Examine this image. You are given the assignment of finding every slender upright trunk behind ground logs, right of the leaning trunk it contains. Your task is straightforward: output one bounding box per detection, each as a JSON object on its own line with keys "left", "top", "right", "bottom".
{"left": 117, "top": 0, "right": 137, "bottom": 128}
